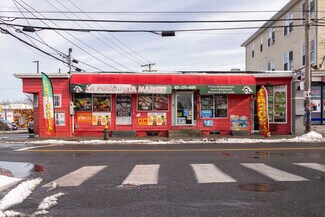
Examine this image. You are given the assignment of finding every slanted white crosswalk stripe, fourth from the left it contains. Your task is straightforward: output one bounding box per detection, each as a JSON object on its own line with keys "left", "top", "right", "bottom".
{"left": 241, "top": 163, "right": 308, "bottom": 182}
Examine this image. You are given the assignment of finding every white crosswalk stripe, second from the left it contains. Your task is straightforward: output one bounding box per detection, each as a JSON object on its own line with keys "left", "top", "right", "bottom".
{"left": 122, "top": 164, "right": 160, "bottom": 186}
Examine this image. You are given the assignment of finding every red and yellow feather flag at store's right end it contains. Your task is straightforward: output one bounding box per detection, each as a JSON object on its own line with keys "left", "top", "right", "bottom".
{"left": 257, "top": 86, "right": 271, "bottom": 138}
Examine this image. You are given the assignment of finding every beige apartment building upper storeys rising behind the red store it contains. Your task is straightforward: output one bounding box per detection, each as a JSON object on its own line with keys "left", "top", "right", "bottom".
{"left": 241, "top": 0, "right": 325, "bottom": 71}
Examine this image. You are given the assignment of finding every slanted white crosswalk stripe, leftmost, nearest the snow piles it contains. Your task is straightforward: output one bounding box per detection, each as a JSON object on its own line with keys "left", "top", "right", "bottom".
{"left": 43, "top": 166, "right": 107, "bottom": 187}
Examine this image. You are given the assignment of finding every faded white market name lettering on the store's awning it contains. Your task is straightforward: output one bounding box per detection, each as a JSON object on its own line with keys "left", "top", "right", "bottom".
{"left": 71, "top": 84, "right": 172, "bottom": 94}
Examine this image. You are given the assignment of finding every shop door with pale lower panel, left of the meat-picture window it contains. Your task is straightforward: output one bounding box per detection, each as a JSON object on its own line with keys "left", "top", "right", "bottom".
{"left": 116, "top": 94, "right": 132, "bottom": 126}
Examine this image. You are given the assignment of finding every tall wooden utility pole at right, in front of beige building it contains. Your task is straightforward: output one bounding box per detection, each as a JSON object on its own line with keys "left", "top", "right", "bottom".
{"left": 304, "top": 0, "right": 311, "bottom": 133}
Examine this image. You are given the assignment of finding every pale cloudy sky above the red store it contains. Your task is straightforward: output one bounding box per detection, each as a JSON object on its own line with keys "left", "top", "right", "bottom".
{"left": 0, "top": 0, "right": 289, "bottom": 102}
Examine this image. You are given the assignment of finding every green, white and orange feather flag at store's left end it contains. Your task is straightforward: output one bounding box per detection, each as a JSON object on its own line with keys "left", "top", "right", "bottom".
{"left": 42, "top": 72, "right": 55, "bottom": 134}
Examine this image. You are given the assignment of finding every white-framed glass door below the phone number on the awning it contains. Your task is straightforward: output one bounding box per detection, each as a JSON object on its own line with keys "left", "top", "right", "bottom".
{"left": 175, "top": 92, "right": 194, "bottom": 125}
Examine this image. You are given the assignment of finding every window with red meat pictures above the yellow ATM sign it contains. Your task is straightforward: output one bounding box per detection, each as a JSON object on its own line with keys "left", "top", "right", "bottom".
{"left": 138, "top": 94, "right": 168, "bottom": 111}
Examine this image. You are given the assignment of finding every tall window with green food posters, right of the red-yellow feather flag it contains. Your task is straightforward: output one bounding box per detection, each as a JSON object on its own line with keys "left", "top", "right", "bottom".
{"left": 266, "top": 85, "right": 287, "bottom": 123}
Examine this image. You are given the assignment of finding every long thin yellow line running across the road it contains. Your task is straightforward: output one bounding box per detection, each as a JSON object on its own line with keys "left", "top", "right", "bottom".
{"left": 22, "top": 146, "right": 325, "bottom": 152}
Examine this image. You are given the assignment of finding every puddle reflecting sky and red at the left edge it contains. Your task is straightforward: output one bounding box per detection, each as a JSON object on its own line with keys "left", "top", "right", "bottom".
{"left": 0, "top": 161, "right": 44, "bottom": 178}
